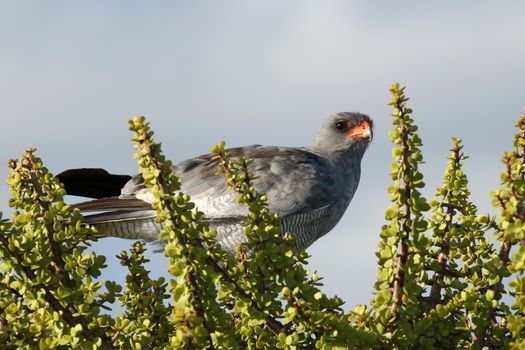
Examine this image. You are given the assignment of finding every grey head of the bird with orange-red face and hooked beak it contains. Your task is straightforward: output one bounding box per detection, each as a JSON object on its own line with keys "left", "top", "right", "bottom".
{"left": 311, "top": 112, "right": 373, "bottom": 157}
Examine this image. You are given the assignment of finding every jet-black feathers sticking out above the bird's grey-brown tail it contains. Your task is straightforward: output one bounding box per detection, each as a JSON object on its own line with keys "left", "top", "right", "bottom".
{"left": 56, "top": 168, "right": 131, "bottom": 198}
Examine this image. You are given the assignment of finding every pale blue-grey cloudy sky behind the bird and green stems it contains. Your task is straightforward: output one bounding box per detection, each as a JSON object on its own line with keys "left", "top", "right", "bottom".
{"left": 0, "top": 0, "right": 525, "bottom": 309}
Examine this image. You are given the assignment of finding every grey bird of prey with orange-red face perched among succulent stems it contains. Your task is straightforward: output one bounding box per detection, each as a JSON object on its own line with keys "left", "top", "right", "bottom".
{"left": 57, "top": 112, "right": 373, "bottom": 253}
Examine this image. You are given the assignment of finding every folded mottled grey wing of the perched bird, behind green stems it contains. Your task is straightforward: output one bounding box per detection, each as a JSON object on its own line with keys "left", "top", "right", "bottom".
{"left": 114, "top": 145, "right": 338, "bottom": 220}
